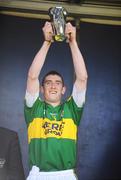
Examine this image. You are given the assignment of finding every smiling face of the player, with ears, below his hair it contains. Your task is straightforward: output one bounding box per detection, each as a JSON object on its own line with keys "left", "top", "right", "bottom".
{"left": 41, "top": 75, "right": 65, "bottom": 105}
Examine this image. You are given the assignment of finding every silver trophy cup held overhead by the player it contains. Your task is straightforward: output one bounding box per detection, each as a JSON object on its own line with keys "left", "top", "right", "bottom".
{"left": 48, "top": 7, "right": 68, "bottom": 41}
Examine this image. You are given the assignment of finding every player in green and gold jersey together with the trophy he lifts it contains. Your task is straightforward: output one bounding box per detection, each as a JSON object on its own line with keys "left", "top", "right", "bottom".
{"left": 24, "top": 7, "right": 87, "bottom": 180}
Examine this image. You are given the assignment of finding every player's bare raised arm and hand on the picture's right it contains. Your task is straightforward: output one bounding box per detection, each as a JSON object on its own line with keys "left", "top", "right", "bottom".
{"left": 65, "top": 23, "right": 88, "bottom": 91}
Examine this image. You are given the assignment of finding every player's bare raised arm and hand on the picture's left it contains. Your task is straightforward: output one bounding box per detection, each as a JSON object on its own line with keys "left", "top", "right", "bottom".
{"left": 27, "top": 22, "right": 53, "bottom": 95}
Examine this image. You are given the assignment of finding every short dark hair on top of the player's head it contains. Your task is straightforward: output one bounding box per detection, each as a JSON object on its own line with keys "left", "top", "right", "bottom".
{"left": 42, "top": 70, "right": 64, "bottom": 86}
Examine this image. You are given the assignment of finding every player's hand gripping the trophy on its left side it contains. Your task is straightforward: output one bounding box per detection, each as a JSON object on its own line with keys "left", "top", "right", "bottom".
{"left": 42, "top": 21, "right": 53, "bottom": 42}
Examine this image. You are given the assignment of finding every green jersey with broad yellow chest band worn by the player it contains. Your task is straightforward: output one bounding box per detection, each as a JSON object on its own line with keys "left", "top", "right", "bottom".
{"left": 24, "top": 97, "right": 83, "bottom": 171}
